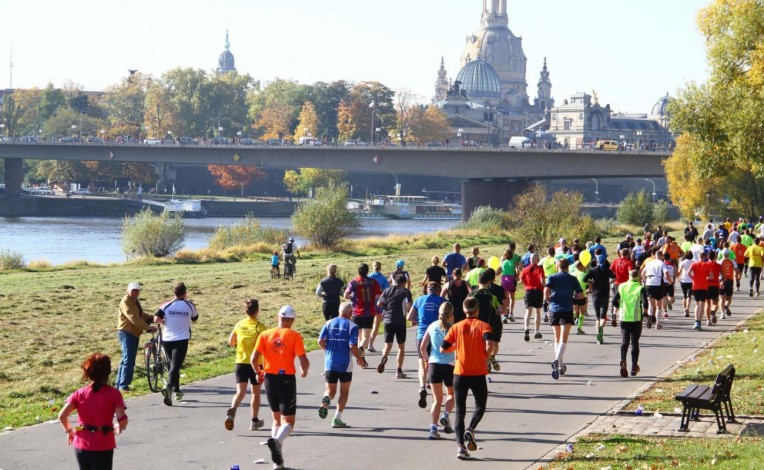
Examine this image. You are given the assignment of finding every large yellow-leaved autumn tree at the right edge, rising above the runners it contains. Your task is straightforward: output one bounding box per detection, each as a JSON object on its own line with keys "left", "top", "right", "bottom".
{"left": 666, "top": 0, "right": 764, "bottom": 217}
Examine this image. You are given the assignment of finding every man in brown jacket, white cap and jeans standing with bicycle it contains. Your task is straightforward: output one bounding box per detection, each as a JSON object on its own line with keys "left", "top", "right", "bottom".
{"left": 115, "top": 282, "right": 156, "bottom": 392}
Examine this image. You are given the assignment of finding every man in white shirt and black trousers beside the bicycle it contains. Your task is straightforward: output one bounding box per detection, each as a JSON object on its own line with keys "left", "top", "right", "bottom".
{"left": 154, "top": 282, "right": 199, "bottom": 406}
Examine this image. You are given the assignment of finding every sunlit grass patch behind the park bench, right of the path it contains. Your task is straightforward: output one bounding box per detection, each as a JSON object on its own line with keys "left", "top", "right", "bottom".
{"left": 626, "top": 312, "right": 764, "bottom": 416}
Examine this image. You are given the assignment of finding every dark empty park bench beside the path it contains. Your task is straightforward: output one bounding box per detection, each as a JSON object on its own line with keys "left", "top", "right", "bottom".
{"left": 674, "top": 364, "right": 737, "bottom": 434}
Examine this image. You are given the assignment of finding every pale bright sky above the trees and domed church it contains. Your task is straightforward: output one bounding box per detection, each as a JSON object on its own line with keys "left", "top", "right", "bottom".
{"left": 0, "top": 0, "right": 708, "bottom": 113}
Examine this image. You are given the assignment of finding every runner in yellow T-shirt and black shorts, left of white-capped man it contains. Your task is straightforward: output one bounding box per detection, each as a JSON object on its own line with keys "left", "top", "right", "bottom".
{"left": 225, "top": 299, "right": 265, "bottom": 431}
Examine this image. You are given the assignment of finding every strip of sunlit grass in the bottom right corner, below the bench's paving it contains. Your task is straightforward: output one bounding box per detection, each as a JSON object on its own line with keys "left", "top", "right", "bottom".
{"left": 545, "top": 434, "right": 764, "bottom": 470}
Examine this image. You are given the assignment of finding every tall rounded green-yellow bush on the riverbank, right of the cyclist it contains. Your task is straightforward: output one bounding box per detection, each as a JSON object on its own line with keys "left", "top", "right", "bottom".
{"left": 292, "top": 184, "right": 360, "bottom": 250}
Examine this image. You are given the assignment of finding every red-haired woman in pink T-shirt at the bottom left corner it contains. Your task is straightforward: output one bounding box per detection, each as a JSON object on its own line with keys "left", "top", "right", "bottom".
{"left": 58, "top": 353, "right": 127, "bottom": 470}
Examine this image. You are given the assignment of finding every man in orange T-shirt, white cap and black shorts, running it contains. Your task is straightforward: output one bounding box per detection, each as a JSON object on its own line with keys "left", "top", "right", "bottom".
{"left": 250, "top": 304, "right": 308, "bottom": 469}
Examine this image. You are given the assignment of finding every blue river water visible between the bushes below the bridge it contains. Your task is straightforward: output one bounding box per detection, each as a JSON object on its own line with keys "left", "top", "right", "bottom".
{"left": 0, "top": 217, "right": 458, "bottom": 265}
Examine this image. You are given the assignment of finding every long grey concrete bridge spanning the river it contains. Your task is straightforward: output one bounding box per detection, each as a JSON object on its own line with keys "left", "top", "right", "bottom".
{"left": 0, "top": 142, "right": 669, "bottom": 216}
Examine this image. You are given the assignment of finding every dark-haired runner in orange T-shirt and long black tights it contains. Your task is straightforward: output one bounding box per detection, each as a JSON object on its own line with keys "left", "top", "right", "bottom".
{"left": 440, "top": 298, "right": 493, "bottom": 460}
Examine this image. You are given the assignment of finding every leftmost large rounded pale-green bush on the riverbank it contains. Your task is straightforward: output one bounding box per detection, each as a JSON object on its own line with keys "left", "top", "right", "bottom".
{"left": 122, "top": 210, "right": 186, "bottom": 258}
